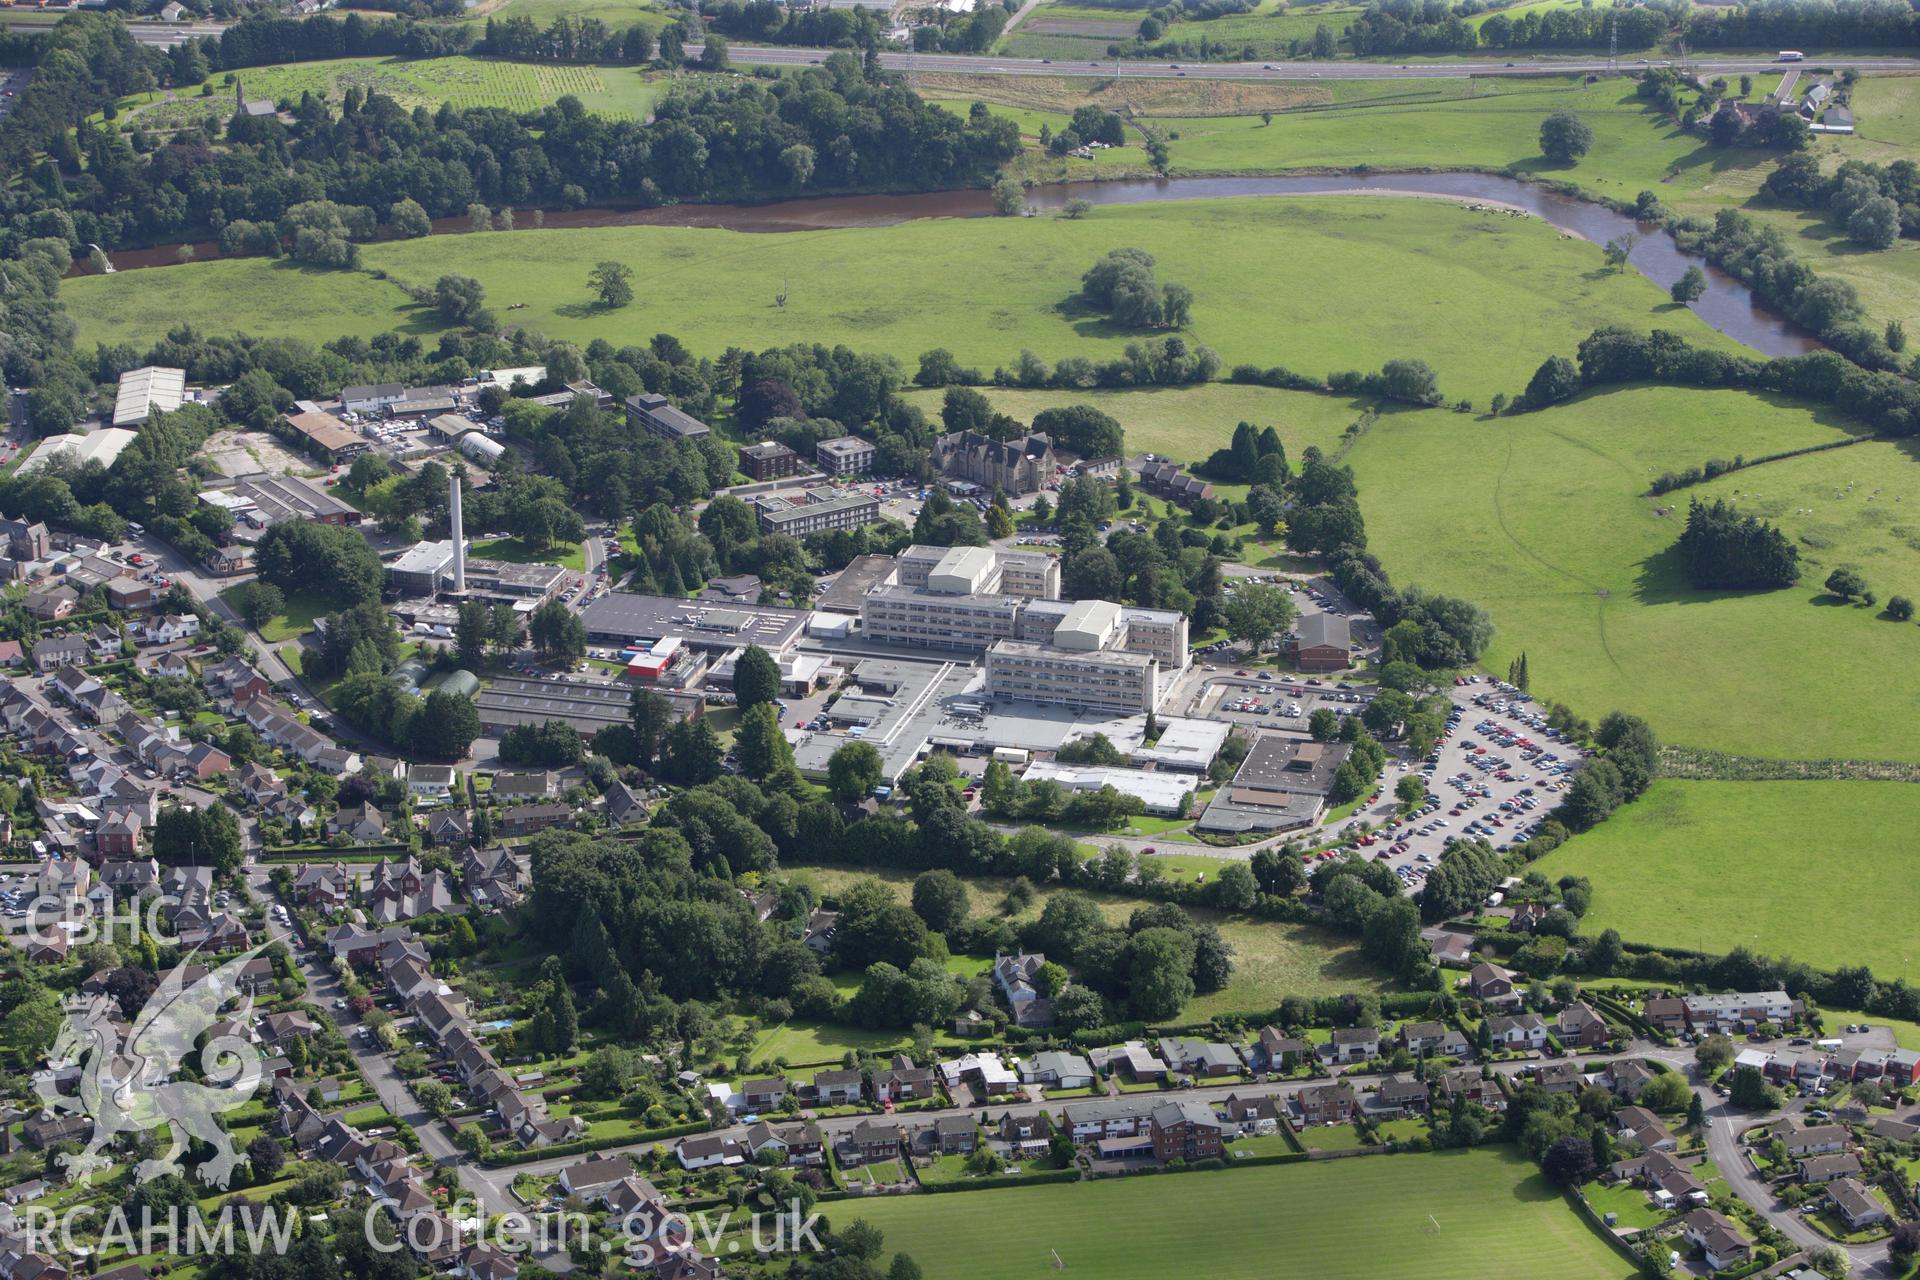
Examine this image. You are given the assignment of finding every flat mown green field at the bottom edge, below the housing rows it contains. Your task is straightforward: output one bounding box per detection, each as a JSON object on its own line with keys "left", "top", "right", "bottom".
{"left": 835, "top": 1150, "right": 1632, "bottom": 1280}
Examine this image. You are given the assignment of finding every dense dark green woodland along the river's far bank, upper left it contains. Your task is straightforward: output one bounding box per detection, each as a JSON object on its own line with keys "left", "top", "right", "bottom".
{"left": 0, "top": 15, "right": 1020, "bottom": 248}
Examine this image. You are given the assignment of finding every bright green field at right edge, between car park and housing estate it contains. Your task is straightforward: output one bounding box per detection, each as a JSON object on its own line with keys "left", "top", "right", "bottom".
{"left": 1538, "top": 781, "right": 1920, "bottom": 982}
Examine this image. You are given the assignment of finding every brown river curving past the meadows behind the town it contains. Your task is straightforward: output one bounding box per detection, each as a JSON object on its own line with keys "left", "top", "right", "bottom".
{"left": 75, "top": 173, "right": 1820, "bottom": 355}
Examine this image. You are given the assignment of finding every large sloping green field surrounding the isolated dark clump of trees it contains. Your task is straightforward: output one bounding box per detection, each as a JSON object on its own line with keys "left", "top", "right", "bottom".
{"left": 1350, "top": 379, "right": 1920, "bottom": 760}
